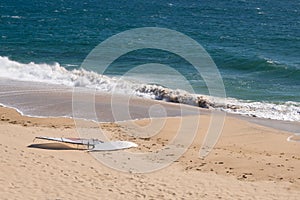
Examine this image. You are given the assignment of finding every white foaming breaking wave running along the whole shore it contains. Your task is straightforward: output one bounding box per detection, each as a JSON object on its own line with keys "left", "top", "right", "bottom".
{"left": 0, "top": 56, "right": 300, "bottom": 121}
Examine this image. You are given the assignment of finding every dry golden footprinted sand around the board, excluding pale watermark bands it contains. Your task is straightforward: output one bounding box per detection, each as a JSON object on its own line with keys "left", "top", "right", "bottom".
{"left": 0, "top": 107, "right": 300, "bottom": 199}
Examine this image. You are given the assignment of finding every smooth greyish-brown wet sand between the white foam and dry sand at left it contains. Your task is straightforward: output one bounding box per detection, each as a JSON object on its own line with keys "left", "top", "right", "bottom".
{"left": 0, "top": 78, "right": 205, "bottom": 122}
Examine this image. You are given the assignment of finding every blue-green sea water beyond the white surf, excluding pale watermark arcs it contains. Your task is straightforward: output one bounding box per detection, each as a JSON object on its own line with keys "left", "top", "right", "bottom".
{"left": 0, "top": 0, "right": 300, "bottom": 120}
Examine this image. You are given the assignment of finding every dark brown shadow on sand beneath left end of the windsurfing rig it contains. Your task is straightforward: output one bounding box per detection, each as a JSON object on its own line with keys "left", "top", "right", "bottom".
{"left": 27, "top": 143, "right": 86, "bottom": 150}
